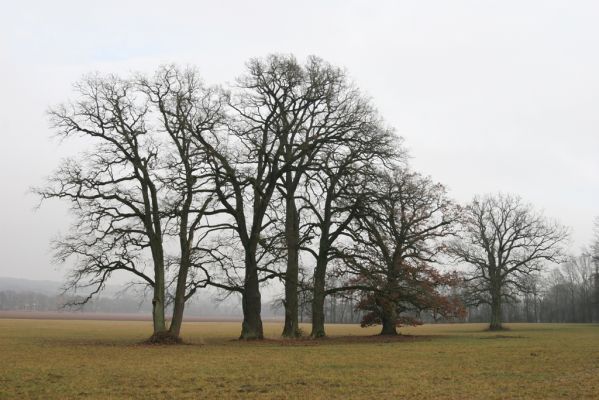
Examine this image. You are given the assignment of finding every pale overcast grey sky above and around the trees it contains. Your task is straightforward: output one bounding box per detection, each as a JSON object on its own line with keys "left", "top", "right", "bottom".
{"left": 0, "top": 0, "right": 599, "bottom": 280}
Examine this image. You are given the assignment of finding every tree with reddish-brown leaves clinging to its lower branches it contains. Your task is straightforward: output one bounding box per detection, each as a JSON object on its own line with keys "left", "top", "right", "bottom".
{"left": 342, "top": 167, "right": 463, "bottom": 335}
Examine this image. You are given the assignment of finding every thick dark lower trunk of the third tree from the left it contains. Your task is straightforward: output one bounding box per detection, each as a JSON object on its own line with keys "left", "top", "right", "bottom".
{"left": 239, "top": 252, "right": 264, "bottom": 340}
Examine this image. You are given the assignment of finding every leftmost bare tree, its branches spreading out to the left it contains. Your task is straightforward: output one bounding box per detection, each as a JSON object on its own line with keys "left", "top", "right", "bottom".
{"left": 37, "top": 76, "right": 171, "bottom": 336}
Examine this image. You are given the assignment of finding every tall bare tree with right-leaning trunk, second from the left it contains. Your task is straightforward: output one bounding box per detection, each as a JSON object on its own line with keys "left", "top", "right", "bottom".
{"left": 137, "top": 66, "right": 226, "bottom": 337}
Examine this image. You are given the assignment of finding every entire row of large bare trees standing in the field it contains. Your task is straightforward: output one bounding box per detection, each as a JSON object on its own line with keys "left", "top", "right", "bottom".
{"left": 37, "top": 55, "right": 566, "bottom": 341}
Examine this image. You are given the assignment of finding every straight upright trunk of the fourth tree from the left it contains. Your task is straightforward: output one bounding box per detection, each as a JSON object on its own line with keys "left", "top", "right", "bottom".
{"left": 282, "top": 197, "right": 301, "bottom": 337}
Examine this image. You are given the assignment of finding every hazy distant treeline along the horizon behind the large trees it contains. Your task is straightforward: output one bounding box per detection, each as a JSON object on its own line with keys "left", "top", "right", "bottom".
{"left": 0, "top": 268, "right": 599, "bottom": 324}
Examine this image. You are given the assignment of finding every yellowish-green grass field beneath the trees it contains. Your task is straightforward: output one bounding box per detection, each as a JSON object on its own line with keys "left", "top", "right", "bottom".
{"left": 0, "top": 319, "right": 599, "bottom": 399}
